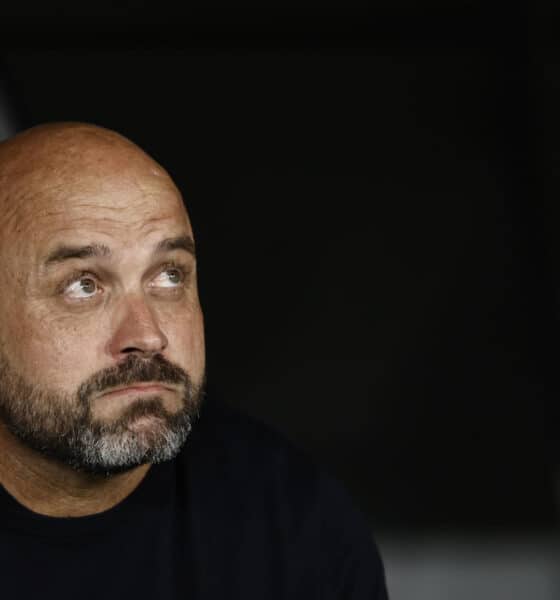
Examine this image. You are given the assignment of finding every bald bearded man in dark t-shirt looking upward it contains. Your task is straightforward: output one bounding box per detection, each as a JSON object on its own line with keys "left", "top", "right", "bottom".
{"left": 0, "top": 123, "right": 386, "bottom": 600}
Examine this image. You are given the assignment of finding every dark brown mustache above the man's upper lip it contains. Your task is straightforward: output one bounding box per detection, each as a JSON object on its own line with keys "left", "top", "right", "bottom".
{"left": 78, "top": 354, "right": 192, "bottom": 403}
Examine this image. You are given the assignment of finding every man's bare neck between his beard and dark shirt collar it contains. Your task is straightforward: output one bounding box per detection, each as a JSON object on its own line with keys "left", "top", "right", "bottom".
{"left": 0, "top": 425, "right": 150, "bottom": 517}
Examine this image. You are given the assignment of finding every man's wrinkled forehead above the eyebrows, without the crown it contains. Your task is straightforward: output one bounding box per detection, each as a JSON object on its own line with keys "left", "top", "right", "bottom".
{"left": 2, "top": 159, "right": 191, "bottom": 251}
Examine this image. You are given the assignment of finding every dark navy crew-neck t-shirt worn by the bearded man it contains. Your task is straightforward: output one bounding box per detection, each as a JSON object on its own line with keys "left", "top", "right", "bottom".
{"left": 0, "top": 403, "right": 387, "bottom": 600}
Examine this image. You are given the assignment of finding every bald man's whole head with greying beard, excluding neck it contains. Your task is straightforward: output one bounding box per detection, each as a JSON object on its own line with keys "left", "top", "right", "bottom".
{"left": 0, "top": 123, "right": 204, "bottom": 473}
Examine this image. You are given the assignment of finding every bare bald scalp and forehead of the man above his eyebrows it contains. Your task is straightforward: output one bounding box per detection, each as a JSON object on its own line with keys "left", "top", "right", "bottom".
{"left": 0, "top": 122, "right": 201, "bottom": 342}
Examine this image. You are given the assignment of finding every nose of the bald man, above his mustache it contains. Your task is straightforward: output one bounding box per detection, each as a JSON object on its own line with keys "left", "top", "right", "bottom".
{"left": 109, "top": 296, "right": 168, "bottom": 360}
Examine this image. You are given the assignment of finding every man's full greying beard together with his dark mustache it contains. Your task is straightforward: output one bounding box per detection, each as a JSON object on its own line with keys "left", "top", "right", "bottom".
{"left": 0, "top": 354, "right": 203, "bottom": 476}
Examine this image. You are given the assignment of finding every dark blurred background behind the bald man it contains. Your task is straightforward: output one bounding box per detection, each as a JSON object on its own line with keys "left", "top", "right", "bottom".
{"left": 0, "top": 0, "right": 560, "bottom": 600}
